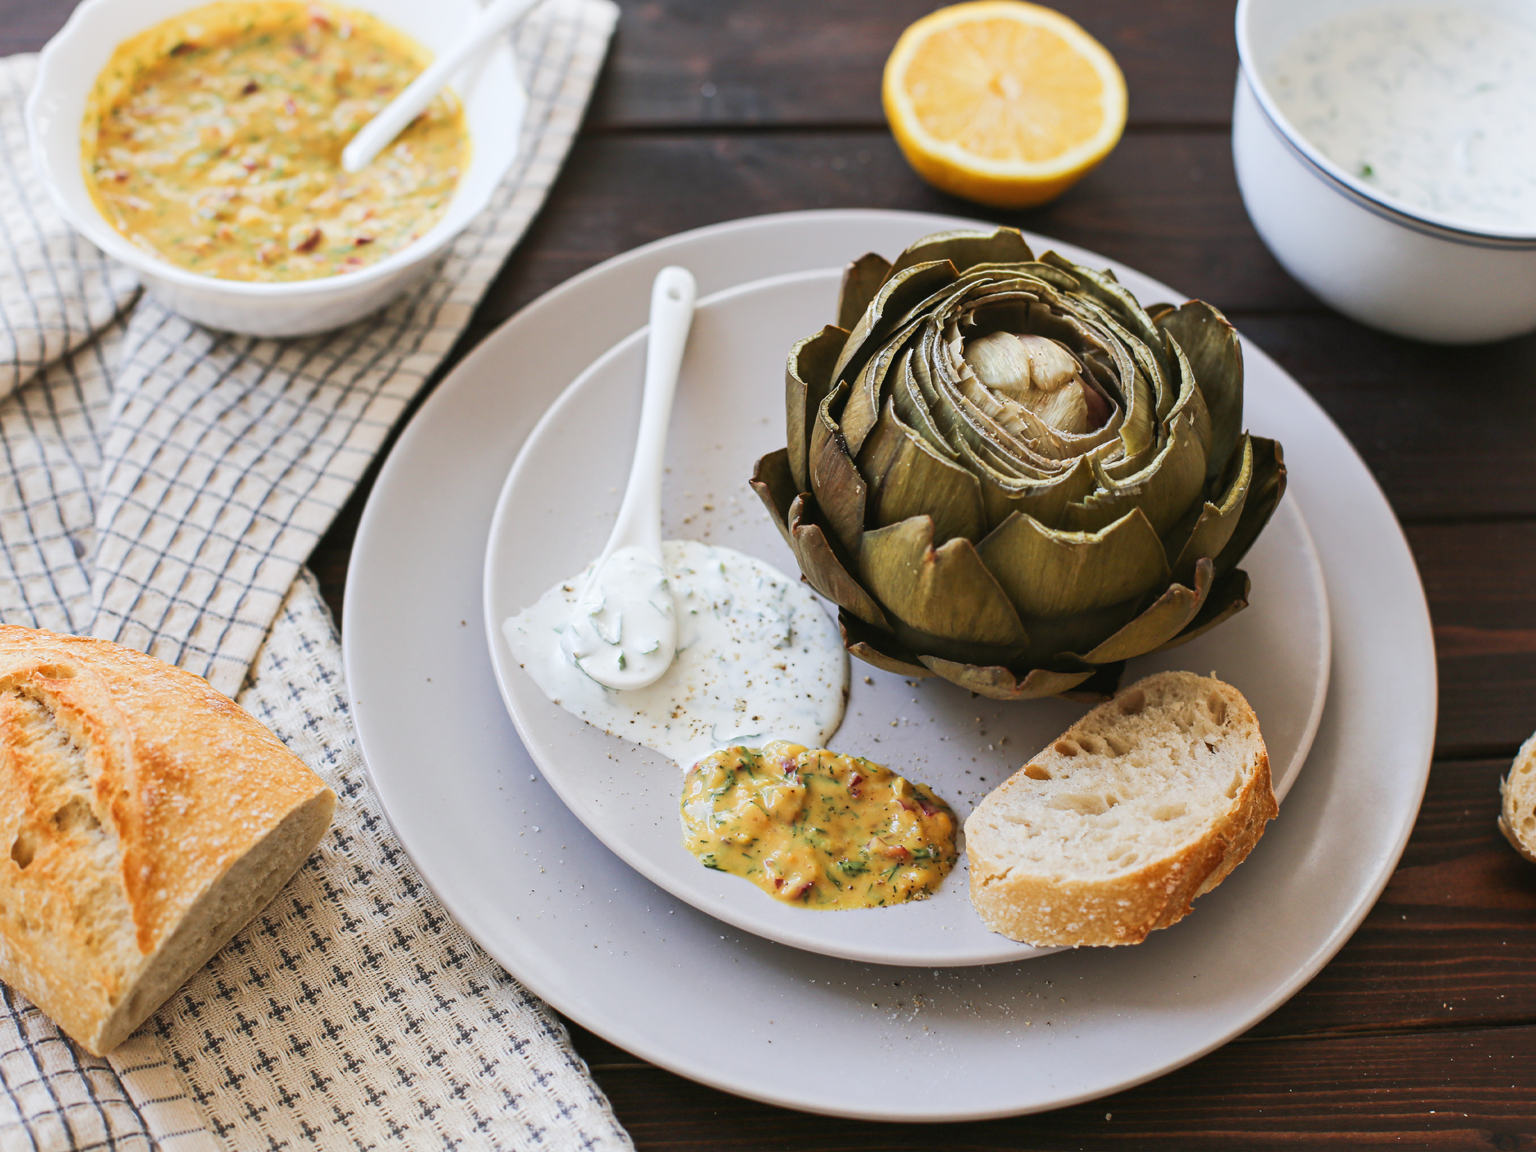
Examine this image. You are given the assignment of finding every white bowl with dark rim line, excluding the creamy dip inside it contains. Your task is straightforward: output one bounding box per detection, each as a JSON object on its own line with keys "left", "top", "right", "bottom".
{"left": 1232, "top": 0, "right": 1536, "bottom": 344}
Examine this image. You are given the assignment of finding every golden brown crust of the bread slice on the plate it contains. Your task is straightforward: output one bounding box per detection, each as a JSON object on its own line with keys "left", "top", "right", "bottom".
{"left": 966, "top": 673, "right": 1279, "bottom": 946}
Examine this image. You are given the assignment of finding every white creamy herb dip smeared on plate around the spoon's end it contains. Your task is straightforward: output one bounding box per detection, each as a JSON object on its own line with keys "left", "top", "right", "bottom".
{"left": 502, "top": 541, "right": 848, "bottom": 768}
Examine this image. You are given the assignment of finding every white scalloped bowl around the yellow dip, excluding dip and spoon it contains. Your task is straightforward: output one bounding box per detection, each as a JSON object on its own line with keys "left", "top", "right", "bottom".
{"left": 26, "top": 0, "right": 527, "bottom": 336}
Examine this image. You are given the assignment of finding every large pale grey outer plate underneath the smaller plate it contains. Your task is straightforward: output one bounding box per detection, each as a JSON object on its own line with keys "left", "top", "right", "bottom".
{"left": 343, "top": 212, "right": 1436, "bottom": 1120}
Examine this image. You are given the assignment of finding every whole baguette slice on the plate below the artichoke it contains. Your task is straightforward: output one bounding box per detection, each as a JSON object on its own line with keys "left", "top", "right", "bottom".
{"left": 965, "top": 671, "right": 1279, "bottom": 946}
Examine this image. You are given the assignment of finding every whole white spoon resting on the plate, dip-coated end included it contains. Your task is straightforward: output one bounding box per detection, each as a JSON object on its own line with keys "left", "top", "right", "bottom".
{"left": 561, "top": 266, "right": 697, "bottom": 690}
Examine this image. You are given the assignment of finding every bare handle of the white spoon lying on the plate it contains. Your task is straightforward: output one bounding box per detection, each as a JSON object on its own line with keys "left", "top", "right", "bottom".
{"left": 599, "top": 266, "right": 697, "bottom": 567}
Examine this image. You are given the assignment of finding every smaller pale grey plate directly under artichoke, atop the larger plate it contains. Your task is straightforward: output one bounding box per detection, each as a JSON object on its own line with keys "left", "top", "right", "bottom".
{"left": 484, "top": 265, "right": 1329, "bottom": 968}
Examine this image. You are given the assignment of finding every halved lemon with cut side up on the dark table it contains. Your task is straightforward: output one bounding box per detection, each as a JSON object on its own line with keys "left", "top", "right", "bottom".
{"left": 882, "top": 0, "right": 1126, "bottom": 207}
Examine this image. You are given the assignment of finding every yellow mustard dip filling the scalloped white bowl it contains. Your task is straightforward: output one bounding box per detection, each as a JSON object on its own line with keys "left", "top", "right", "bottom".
{"left": 83, "top": 0, "right": 470, "bottom": 280}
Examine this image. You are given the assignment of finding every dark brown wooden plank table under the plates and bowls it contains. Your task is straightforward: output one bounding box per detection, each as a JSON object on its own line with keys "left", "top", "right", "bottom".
{"left": 12, "top": 0, "right": 1536, "bottom": 1152}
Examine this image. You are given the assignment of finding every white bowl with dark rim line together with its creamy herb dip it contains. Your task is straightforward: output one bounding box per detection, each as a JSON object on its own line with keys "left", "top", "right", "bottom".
{"left": 1232, "top": 0, "right": 1536, "bottom": 344}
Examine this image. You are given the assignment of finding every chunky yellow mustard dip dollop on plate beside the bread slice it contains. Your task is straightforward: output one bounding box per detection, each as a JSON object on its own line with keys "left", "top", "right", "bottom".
{"left": 682, "top": 740, "right": 955, "bottom": 909}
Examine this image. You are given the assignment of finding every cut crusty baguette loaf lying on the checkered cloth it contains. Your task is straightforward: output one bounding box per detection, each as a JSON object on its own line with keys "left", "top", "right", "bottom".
{"left": 0, "top": 625, "right": 336, "bottom": 1055}
